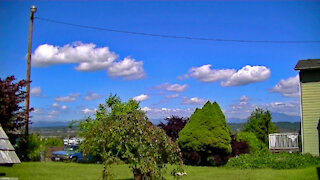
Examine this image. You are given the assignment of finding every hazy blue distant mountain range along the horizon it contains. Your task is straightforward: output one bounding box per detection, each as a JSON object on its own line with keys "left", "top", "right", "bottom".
{"left": 31, "top": 112, "right": 300, "bottom": 127}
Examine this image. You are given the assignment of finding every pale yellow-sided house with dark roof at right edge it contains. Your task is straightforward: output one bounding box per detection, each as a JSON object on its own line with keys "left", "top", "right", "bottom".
{"left": 294, "top": 59, "right": 320, "bottom": 155}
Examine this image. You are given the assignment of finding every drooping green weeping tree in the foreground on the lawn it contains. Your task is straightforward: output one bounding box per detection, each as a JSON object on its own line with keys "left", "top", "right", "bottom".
{"left": 79, "top": 95, "right": 182, "bottom": 179}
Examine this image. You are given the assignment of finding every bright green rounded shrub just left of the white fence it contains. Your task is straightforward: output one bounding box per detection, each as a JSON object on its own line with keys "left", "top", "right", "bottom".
{"left": 236, "top": 132, "right": 268, "bottom": 154}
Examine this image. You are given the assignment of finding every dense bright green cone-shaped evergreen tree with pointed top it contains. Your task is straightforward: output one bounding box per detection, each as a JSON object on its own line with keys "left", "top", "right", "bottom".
{"left": 178, "top": 101, "right": 231, "bottom": 164}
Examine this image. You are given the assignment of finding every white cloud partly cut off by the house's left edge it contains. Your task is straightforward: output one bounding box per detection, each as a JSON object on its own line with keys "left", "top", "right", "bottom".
{"left": 270, "top": 75, "right": 300, "bottom": 97}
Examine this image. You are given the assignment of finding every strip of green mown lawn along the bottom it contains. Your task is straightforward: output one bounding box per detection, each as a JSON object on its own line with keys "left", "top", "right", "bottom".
{"left": 0, "top": 162, "right": 318, "bottom": 180}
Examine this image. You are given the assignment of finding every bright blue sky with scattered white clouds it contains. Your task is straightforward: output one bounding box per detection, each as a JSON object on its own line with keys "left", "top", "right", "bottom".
{"left": 0, "top": 1, "right": 320, "bottom": 122}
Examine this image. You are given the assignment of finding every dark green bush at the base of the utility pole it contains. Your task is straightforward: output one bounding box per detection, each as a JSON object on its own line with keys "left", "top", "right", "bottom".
{"left": 17, "top": 133, "right": 44, "bottom": 161}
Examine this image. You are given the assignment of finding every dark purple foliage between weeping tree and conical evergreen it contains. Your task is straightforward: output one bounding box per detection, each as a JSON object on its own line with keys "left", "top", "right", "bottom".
{"left": 158, "top": 116, "right": 189, "bottom": 141}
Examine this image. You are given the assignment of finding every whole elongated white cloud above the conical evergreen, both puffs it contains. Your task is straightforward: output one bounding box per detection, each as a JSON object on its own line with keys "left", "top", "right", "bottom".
{"left": 185, "top": 64, "right": 271, "bottom": 86}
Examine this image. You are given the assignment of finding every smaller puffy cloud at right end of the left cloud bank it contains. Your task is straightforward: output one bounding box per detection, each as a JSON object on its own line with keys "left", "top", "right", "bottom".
{"left": 107, "top": 57, "right": 145, "bottom": 80}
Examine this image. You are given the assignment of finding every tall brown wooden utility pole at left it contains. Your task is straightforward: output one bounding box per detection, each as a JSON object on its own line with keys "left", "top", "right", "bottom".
{"left": 25, "top": 6, "right": 37, "bottom": 138}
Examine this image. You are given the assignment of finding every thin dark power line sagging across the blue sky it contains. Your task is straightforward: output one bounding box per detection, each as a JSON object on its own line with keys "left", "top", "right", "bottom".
{"left": 35, "top": 17, "right": 320, "bottom": 44}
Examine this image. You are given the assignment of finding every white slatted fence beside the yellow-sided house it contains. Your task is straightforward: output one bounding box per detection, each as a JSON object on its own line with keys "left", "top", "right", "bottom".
{"left": 269, "top": 133, "right": 299, "bottom": 152}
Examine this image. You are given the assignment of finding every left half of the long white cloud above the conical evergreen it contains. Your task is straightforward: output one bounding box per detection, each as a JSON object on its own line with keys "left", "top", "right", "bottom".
{"left": 189, "top": 64, "right": 236, "bottom": 82}
